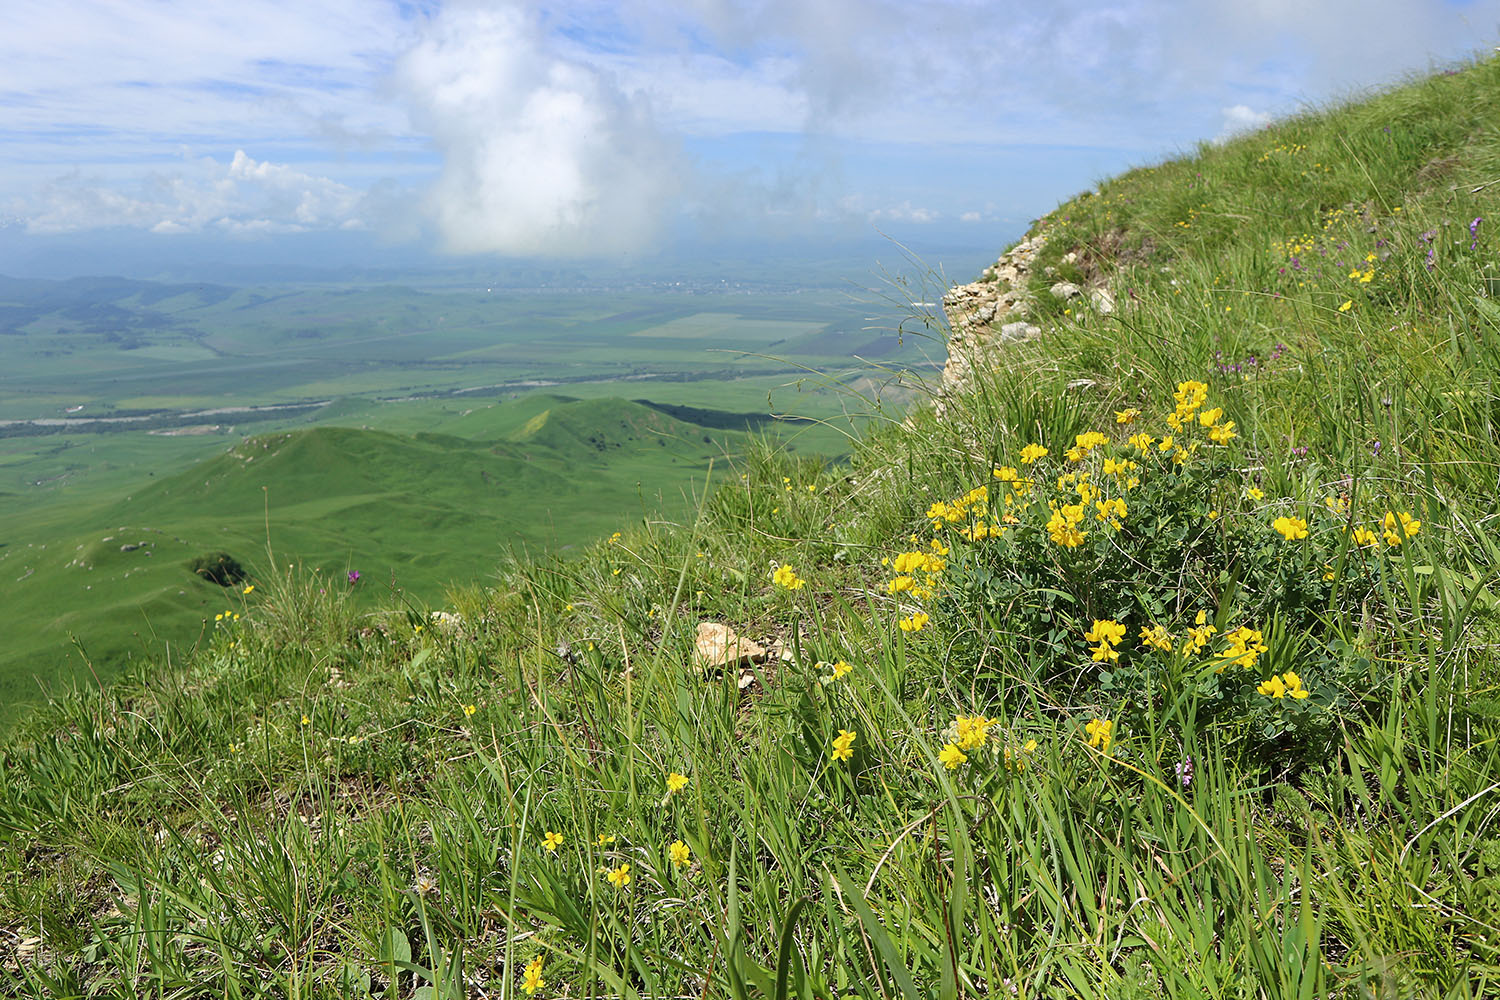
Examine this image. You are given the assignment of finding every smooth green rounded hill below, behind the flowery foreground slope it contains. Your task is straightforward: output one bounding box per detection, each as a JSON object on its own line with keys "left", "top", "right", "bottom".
{"left": 0, "top": 396, "right": 740, "bottom": 716}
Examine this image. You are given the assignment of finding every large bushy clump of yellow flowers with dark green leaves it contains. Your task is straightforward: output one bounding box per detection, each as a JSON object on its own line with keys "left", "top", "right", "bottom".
{"left": 885, "top": 379, "right": 1422, "bottom": 758}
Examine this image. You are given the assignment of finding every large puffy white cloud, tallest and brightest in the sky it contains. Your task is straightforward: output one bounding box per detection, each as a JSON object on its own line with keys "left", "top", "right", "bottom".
{"left": 396, "top": 6, "right": 680, "bottom": 255}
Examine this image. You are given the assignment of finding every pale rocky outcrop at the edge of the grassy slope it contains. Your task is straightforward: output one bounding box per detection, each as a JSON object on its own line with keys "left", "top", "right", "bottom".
{"left": 938, "top": 234, "right": 1046, "bottom": 414}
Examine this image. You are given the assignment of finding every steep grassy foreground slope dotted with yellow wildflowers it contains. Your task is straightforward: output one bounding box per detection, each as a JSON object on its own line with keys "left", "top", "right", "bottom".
{"left": 0, "top": 60, "right": 1500, "bottom": 999}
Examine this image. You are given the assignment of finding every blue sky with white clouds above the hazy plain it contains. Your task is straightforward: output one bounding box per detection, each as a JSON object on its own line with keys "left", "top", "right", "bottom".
{"left": 0, "top": 0, "right": 1500, "bottom": 273}
